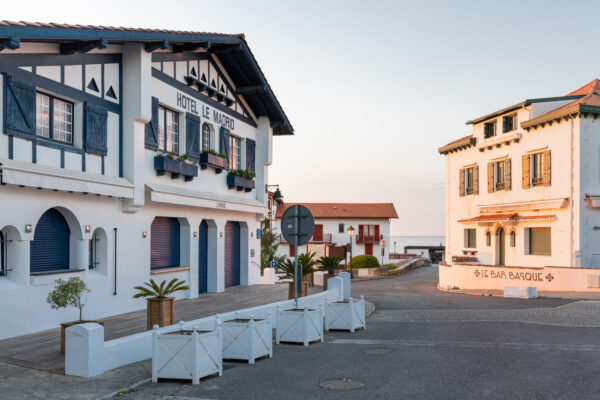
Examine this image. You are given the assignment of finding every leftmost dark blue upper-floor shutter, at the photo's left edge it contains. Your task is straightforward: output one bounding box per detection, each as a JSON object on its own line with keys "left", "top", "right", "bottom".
{"left": 4, "top": 74, "right": 35, "bottom": 139}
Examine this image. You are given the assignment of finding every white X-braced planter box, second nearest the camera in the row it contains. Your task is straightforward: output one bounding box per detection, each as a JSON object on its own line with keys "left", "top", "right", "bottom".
{"left": 221, "top": 312, "right": 273, "bottom": 364}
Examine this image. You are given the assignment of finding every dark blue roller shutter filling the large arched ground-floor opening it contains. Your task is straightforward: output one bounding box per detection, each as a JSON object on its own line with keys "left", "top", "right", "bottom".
{"left": 29, "top": 208, "right": 70, "bottom": 273}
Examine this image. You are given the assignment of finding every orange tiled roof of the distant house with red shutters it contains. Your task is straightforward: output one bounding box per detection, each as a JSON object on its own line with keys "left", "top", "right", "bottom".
{"left": 276, "top": 203, "right": 398, "bottom": 218}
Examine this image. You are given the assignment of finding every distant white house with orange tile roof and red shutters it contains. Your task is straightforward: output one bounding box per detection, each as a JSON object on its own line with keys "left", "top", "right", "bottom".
{"left": 275, "top": 202, "right": 398, "bottom": 263}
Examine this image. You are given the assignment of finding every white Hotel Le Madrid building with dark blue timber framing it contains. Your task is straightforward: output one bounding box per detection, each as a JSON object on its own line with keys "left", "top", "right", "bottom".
{"left": 0, "top": 21, "right": 293, "bottom": 339}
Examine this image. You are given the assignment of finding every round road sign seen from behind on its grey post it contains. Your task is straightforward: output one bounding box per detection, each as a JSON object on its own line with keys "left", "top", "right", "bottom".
{"left": 281, "top": 205, "right": 315, "bottom": 306}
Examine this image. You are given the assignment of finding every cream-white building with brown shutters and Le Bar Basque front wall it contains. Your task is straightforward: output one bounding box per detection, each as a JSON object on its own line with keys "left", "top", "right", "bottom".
{"left": 439, "top": 79, "right": 600, "bottom": 291}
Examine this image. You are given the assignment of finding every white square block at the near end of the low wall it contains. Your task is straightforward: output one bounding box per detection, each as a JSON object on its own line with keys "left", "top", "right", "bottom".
{"left": 65, "top": 322, "right": 104, "bottom": 378}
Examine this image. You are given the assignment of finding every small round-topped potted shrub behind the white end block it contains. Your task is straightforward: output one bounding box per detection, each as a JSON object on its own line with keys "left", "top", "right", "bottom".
{"left": 46, "top": 276, "right": 104, "bottom": 354}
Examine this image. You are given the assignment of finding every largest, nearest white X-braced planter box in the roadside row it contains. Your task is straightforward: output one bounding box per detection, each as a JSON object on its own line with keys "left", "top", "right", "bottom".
{"left": 152, "top": 325, "right": 223, "bottom": 385}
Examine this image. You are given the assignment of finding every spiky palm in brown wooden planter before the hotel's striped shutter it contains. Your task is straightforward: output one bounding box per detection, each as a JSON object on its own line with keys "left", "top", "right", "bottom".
{"left": 133, "top": 278, "right": 190, "bottom": 330}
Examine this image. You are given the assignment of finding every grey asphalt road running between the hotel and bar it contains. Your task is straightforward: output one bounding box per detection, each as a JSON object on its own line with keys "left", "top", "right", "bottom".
{"left": 120, "top": 267, "right": 600, "bottom": 400}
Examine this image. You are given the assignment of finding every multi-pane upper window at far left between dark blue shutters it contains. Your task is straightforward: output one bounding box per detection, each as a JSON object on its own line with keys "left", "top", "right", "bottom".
{"left": 35, "top": 93, "right": 73, "bottom": 143}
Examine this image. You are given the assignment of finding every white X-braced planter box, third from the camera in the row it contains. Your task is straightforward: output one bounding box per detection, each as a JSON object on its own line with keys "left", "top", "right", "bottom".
{"left": 276, "top": 304, "right": 323, "bottom": 346}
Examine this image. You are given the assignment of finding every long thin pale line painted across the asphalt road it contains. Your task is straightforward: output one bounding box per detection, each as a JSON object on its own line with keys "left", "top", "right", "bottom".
{"left": 326, "top": 339, "right": 600, "bottom": 351}
